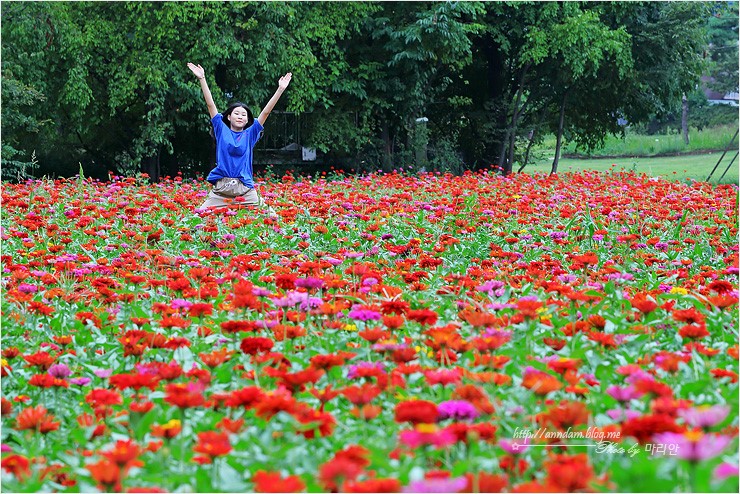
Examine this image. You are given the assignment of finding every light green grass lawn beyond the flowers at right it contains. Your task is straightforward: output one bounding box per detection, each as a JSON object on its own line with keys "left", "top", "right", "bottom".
{"left": 524, "top": 150, "right": 740, "bottom": 183}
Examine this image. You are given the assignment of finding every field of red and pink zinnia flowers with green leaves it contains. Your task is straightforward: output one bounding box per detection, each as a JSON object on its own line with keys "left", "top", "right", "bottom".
{"left": 1, "top": 172, "right": 738, "bottom": 492}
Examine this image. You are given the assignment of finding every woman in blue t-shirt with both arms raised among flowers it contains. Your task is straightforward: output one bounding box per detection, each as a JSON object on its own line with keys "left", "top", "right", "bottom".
{"left": 188, "top": 63, "right": 293, "bottom": 213}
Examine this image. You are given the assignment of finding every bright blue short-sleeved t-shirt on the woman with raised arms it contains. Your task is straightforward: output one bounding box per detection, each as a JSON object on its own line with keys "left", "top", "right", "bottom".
{"left": 206, "top": 113, "right": 264, "bottom": 187}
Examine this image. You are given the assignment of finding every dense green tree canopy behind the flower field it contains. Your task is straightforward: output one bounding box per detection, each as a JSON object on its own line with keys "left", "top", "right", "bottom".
{"left": 2, "top": 2, "right": 737, "bottom": 179}
